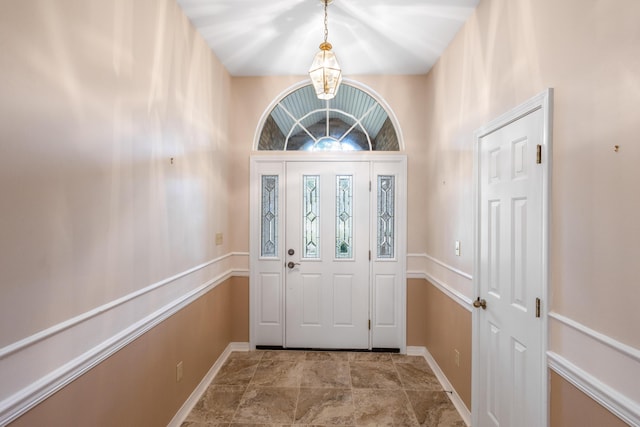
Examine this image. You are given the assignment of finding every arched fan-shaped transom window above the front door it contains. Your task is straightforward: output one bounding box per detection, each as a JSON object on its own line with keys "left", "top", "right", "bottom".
{"left": 258, "top": 82, "right": 400, "bottom": 151}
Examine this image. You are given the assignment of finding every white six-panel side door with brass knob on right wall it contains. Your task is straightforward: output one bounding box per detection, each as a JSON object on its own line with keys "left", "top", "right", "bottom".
{"left": 473, "top": 91, "right": 547, "bottom": 427}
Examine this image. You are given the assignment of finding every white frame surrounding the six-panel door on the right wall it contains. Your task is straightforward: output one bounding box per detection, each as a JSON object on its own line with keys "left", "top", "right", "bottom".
{"left": 471, "top": 88, "right": 553, "bottom": 427}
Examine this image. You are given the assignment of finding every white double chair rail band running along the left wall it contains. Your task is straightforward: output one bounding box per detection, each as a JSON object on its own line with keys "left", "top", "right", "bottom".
{"left": 0, "top": 252, "right": 249, "bottom": 425}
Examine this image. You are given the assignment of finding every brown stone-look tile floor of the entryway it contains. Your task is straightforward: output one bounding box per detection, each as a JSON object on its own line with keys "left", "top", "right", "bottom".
{"left": 182, "top": 351, "right": 465, "bottom": 427}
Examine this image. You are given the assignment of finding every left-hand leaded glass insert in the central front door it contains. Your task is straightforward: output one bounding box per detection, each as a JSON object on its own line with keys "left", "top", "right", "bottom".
{"left": 302, "top": 175, "right": 320, "bottom": 258}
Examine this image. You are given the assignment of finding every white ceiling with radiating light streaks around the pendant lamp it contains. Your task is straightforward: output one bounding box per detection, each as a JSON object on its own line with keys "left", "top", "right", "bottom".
{"left": 177, "top": 0, "right": 479, "bottom": 77}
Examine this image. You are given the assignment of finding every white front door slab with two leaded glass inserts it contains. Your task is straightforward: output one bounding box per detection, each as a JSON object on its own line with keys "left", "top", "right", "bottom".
{"left": 285, "top": 162, "right": 370, "bottom": 349}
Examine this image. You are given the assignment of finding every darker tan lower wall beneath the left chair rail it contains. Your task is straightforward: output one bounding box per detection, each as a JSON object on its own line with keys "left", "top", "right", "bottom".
{"left": 10, "top": 277, "right": 249, "bottom": 427}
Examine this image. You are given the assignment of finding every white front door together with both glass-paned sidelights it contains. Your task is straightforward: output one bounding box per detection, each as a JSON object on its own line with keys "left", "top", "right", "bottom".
{"left": 251, "top": 158, "right": 406, "bottom": 349}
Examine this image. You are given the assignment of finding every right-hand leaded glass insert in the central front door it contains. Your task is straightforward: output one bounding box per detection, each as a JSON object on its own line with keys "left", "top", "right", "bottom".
{"left": 336, "top": 175, "right": 353, "bottom": 259}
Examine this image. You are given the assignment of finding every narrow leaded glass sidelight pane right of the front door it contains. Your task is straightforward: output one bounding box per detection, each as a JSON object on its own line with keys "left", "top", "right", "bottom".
{"left": 378, "top": 175, "right": 395, "bottom": 258}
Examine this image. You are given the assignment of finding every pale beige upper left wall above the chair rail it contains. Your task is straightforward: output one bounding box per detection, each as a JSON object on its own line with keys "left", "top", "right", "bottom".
{"left": 0, "top": 0, "right": 230, "bottom": 348}
